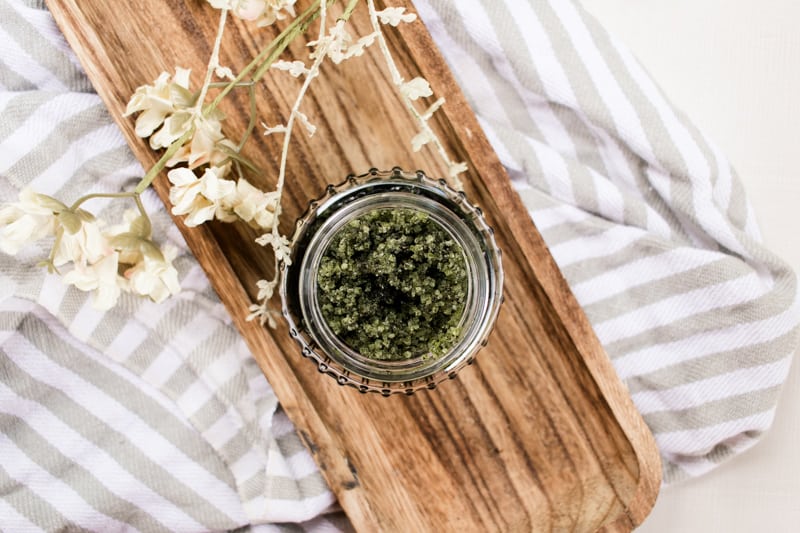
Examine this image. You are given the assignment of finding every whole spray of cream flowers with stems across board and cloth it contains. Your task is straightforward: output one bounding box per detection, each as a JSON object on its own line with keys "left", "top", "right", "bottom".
{"left": 0, "top": 0, "right": 466, "bottom": 316}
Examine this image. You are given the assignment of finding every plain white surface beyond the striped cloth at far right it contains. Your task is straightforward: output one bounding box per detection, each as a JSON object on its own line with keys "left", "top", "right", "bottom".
{"left": 583, "top": 0, "right": 800, "bottom": 533}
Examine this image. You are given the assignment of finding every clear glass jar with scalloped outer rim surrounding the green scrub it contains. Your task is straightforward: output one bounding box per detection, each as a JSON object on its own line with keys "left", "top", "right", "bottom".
{"left": 280, "top": 168, "right": 503, "bottom": 396}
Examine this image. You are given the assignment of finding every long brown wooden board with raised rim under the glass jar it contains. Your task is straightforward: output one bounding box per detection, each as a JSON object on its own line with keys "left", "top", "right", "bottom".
{"left": 47, "top": 0, "right": 661, "bottom": 532}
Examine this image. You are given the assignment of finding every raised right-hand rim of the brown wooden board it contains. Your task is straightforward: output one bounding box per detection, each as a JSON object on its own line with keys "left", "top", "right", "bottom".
{"left": 398, "top": 0, "right": 662, "bottom": 529}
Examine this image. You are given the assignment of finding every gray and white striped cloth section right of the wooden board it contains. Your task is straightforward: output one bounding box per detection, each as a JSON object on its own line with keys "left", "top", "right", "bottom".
{"left": 416, "top": 0, "right": 800, "bottom": 483}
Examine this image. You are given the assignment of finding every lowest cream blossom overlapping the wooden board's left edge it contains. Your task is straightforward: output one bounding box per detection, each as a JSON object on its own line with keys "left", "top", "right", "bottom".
{"left": 167, "top": 167, "right": 236, "bottom": 227}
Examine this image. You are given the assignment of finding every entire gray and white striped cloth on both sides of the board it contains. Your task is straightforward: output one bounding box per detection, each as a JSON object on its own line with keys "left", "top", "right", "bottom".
{"left": 0, "top": 0, "right": 800, "bottom": 531}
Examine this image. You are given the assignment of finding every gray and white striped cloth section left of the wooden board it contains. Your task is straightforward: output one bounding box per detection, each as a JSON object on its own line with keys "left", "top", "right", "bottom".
{"left": 0, "top": 0, "right": 342, "bottom": 531}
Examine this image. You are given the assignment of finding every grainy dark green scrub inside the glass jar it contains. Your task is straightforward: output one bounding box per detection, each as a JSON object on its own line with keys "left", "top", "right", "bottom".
{"left": 317, "top": 208, "right": 467, "bottom": 360}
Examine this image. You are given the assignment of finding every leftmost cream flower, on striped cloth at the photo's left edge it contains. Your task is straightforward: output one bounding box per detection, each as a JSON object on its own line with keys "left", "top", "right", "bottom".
{"left": 0, "top": 188, "right": 59, "bottom": 255}
